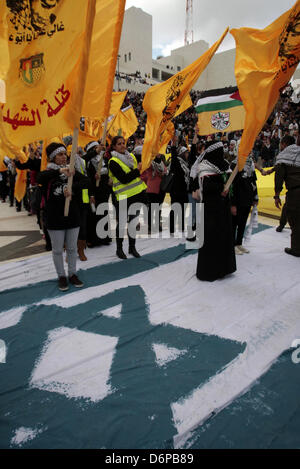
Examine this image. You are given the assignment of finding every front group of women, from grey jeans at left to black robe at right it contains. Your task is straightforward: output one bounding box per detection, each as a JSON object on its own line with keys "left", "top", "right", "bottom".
{"left": 28, "top": 128, "right": 257, "bottom": 291}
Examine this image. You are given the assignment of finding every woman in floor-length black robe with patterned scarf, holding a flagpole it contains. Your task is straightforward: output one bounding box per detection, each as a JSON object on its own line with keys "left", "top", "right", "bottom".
{"left": 196, "top": 142, "right": 236, "bottom": 282}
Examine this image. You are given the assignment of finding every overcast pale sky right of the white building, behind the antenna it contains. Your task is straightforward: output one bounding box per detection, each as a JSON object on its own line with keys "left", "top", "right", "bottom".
{"left": 126, "top": 0, "right": 296, "bottom": 59}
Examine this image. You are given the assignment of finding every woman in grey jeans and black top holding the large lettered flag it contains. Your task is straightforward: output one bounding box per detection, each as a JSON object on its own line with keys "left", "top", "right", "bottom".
{"left": 37, "top": 142, "right": 89, "bottom": 291}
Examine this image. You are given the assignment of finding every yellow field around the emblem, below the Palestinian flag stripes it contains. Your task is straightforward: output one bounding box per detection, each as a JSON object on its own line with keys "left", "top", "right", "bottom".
{"left": 198, "top": 106, "right": 245, "bottom": 135}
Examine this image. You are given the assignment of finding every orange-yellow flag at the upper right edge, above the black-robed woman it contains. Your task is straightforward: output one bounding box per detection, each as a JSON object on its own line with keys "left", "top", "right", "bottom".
{"left": 230, "top": 0, "right": 300, "bottom": 170}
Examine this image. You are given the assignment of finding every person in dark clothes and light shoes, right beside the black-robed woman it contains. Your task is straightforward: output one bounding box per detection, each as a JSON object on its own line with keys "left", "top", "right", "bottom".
{"left": 231, "top": 154, "right": 258, "bottom": 254}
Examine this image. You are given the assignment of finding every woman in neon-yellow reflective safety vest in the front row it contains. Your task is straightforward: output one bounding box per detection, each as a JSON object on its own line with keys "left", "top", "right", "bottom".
{"left": 109, "top": 136, "right": 147, "bottom": 259}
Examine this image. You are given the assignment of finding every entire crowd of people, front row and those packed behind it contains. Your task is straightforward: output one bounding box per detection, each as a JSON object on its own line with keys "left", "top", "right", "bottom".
{"left": 0, "top": 87, "right": 300, "bottom": 291}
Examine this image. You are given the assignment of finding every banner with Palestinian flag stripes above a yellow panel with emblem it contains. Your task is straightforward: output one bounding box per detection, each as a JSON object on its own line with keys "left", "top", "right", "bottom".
{"left": 195, "top": 92, "right": 245, "bottom": 135}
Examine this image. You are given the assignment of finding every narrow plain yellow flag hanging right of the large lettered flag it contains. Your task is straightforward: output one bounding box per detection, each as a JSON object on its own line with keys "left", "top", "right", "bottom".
{"left": 81, "top": 0, "right": 126, "bottom": 121}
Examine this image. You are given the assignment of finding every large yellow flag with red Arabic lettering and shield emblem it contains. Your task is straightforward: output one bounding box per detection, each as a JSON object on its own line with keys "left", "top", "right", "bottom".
{"left": 0, "top": 0, "right": 96, "bottom": 148}
